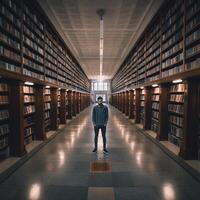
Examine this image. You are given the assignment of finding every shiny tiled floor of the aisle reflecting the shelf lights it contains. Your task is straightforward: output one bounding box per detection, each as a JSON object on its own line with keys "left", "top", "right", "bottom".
{"left": 0, "top": 105, "right": 200, "bottom": 200}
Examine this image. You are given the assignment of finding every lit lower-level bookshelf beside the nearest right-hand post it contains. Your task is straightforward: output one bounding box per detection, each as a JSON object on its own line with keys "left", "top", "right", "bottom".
{"left": 168, "top": 83, "right": 186, "bottom": 147}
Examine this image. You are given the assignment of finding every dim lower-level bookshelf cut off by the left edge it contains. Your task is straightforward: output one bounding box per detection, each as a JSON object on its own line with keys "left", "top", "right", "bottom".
{"left": 0, "top": 79, "right": 10, "bottom": 152}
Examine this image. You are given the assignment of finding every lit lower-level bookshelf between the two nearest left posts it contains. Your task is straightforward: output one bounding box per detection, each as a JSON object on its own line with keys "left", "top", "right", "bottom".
{"left": 23, "top": 84, "right": 36, "bottom": 145}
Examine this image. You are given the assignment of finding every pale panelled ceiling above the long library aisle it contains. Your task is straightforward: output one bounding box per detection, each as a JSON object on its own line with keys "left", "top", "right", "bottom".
{"left": 38, "top": 0, "right": 163, "bottom": 79}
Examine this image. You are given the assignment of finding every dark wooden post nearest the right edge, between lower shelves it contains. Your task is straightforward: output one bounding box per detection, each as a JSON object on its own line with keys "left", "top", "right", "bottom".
{"left": 179, "top": 79, "right": 200, "bottom": 160}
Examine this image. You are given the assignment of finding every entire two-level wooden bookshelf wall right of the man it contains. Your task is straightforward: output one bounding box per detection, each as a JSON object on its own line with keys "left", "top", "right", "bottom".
{"left": 111, "top": 0, "right": 200, "bottom": 159}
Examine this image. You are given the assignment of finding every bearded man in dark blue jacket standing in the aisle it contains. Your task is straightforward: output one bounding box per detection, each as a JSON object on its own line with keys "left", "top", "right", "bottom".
{"left": 92, "top": 97, "right": 108, "bottom": 153}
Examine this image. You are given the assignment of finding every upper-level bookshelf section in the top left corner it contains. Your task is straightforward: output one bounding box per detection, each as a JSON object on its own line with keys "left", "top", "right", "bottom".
{"left": 0, "top": 1, "right": 21, "bottom": 73}
